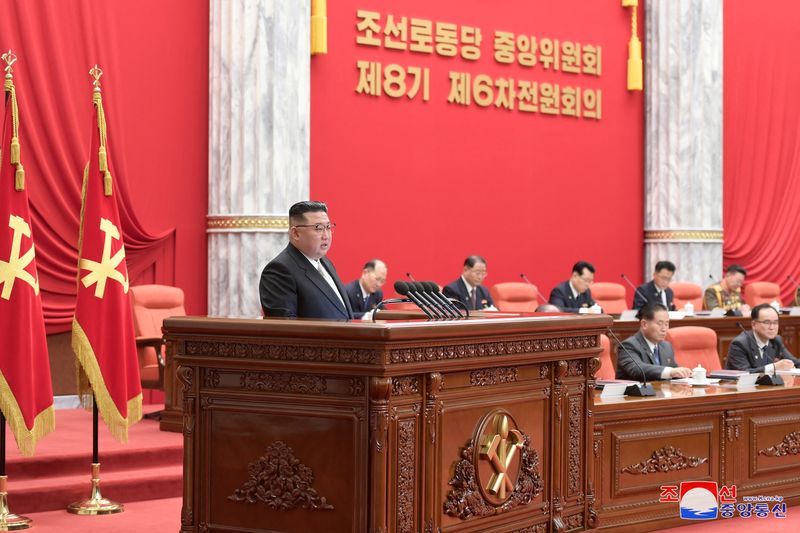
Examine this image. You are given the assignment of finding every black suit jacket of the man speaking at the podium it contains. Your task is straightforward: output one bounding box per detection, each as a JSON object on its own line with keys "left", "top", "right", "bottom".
{"left": 258, "top": 243, "right": 353, "bottom": 320}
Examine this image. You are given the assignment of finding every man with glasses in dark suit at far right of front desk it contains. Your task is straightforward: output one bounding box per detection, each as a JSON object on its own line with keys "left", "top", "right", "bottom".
{"left": 725, "top": 304, "right": 800, "bottom": 374}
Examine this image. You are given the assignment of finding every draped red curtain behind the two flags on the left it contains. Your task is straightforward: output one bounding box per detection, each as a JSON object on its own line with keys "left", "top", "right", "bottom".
{"left": 0, "top": 0, "right": 208, "bottom": 333}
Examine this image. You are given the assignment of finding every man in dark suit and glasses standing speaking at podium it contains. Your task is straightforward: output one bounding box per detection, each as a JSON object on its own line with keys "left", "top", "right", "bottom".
{"left": 258, "top": 198, "right": 353, "bottom": 320}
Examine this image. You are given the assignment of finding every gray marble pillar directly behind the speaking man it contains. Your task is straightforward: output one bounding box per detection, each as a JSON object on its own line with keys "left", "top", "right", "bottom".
{"left": 208, "top": 0, "right": 311, "bottom": 317}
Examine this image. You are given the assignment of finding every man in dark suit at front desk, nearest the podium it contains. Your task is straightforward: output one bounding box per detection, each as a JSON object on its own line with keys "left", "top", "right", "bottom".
{"left": 617, "top": 303, "right": 692, "bottom": 381}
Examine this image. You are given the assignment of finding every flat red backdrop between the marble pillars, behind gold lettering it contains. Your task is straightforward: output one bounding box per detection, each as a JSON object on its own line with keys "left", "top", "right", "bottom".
{"left": 311, "top": 0, "right": 644, "bottom": 295}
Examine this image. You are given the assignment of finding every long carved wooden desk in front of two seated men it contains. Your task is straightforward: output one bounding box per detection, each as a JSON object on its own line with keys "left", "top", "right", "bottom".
{"left": 593, "top": 376, "right": 800, "bottom": 531}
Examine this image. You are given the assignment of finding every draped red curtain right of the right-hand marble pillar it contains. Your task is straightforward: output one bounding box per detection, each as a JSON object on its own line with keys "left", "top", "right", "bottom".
{"left": 723, "top": 0, "right": 800, "bottom": 304}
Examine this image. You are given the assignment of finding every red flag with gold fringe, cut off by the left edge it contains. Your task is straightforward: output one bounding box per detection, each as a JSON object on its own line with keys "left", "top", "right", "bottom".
{"left": 0, "top": 61, "right": 55, "bottom": 455}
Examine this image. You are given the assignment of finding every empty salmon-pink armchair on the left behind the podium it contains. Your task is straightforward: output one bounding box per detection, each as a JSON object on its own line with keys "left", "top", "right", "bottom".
{"left": 130, "top": 285, "right": 186, "bottom": 388}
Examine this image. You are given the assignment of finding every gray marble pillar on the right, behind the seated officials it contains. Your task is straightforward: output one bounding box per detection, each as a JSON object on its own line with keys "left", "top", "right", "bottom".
{"left": 644, "top": 0, "right": 723, "bottom": 286}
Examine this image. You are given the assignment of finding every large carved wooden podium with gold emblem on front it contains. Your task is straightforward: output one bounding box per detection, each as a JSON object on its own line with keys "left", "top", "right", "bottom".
{"left": 164, "top": 316, "right": 611, "bottom": 533}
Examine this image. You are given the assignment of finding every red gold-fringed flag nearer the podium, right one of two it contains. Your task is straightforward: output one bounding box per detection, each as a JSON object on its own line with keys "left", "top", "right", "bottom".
{"left": 72, "top": 65, "right": 142, "bottom": 442}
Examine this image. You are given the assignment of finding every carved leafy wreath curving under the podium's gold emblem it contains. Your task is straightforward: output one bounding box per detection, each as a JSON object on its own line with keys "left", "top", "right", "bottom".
{"left": 444, "top": 433, "right": 544, "bottom": 520}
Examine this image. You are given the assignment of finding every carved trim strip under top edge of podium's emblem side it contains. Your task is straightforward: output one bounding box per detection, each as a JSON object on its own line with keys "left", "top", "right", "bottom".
{"left": 389, "top": 335, "right": 597, "bottom": 363}
